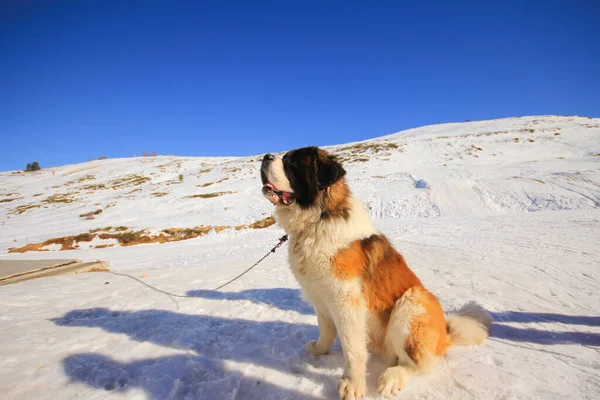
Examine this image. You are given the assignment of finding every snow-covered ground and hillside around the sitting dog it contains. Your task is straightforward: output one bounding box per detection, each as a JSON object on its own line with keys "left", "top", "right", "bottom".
{"left": 0, "top": 116, "right": 600, "bottom": 400}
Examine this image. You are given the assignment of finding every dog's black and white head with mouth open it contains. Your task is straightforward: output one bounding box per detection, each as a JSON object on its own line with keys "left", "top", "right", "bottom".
{"left": 260, "top": 147, "right": 346, "bottom": 208}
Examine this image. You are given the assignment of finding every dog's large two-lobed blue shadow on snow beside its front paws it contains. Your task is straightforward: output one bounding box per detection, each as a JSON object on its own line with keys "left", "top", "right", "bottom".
{"left": 51, "top": 308, "right": 352, "bottom": 399}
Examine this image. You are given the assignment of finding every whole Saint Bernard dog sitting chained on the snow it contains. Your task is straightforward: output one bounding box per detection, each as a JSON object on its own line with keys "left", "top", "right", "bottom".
{"left": 261, "top": 147, "right": 492, "bottom": 400}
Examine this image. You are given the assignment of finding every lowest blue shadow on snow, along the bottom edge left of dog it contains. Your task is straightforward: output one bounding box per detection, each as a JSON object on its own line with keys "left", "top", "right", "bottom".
{"left": 63, "top": 353, "right": 320, "bottom": 400}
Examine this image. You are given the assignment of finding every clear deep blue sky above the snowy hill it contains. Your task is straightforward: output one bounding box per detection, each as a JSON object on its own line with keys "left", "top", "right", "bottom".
{"left": 0, "top": 0, "right": 600, "bottom": 170}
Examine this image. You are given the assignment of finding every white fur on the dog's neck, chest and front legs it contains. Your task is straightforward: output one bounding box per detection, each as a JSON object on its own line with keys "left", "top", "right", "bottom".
{"left": 273, "top": 194, "right": 379, "bottom": 399}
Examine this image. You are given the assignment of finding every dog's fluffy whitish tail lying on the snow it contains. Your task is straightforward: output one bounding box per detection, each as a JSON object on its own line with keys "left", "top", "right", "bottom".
{"left": 446, "top": 302, "right": 492, "bottom": 346}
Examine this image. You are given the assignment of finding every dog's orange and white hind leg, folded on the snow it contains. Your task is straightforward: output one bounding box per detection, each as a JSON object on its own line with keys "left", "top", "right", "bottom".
{"left": 378, "top": 287, "right": 446, "bottom": 396}
